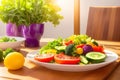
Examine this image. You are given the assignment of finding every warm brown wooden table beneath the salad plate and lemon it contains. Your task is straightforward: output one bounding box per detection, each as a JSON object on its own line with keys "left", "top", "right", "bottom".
{"left": 0, "top": 39, "right": 120, "bottom": 80}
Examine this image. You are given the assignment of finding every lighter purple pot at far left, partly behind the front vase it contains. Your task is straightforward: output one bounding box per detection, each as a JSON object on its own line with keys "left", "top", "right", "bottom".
{"left": 6, "top": 23, "right": 23, "bottom": 37}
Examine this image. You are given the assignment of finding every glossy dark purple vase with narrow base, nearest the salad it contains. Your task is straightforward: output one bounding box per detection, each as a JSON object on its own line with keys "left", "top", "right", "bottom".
{"left": 22, "top": 24, "right": 44, "bottom": 47}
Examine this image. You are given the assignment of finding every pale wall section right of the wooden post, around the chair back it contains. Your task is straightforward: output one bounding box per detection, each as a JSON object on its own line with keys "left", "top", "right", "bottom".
{"left": 80, "top": 0, "right": 120, "bottom": 34}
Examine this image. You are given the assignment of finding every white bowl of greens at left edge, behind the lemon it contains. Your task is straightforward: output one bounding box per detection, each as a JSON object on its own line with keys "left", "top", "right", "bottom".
{"left": 0, "top": 36, "right": 25, "bottom": 49}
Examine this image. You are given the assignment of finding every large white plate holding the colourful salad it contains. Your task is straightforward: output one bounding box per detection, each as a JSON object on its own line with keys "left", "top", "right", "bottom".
{"left": 26, "top": 50, "right": 118, "bottom": 72}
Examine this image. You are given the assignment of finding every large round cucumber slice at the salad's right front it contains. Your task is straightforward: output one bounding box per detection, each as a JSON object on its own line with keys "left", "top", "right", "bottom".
{"left": 86, "top": 52, "right": 106, "bottom": 63}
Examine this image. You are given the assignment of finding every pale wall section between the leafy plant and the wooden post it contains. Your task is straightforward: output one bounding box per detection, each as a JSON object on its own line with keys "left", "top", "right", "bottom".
{"left": 43, "top": 0, "right": 74, "bottom": 38}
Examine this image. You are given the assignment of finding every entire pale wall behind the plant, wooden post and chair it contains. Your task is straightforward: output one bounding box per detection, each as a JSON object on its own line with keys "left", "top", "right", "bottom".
{"left": 0, "top": 0, "right": 120, "bottom": 38}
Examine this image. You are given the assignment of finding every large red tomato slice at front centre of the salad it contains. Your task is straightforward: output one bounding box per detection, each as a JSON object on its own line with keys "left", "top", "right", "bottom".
{"left": 54, "top": 53, "right": 80, "bottom": 64}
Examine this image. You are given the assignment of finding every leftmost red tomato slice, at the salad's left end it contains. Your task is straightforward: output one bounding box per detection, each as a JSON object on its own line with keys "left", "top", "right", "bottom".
{"left": 34, "top": 54, "right": 54, "bottom": 62}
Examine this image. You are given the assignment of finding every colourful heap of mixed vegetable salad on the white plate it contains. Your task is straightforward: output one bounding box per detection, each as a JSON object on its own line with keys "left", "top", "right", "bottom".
{"left": 34, "top": 35, "right": 106, "bottom": 65}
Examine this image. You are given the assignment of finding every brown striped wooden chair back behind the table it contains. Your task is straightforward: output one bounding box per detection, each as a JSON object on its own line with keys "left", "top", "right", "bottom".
{"left": 86, "top": 6, "right": 120, "bottom": 41}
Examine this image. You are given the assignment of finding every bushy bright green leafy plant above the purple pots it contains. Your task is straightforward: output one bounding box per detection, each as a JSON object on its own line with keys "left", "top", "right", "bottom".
{"left": 0, "top": 0, "right": 63, "bottom": 26}
